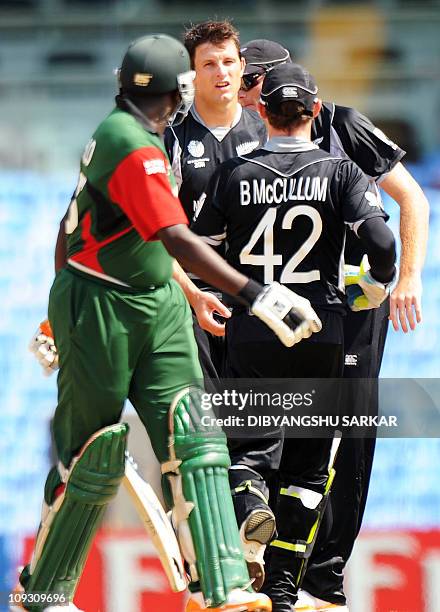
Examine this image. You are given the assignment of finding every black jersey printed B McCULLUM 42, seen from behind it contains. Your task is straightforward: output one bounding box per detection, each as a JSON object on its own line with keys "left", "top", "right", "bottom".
{"left": 193, "top": 137, "right": 385, "bottom": 311}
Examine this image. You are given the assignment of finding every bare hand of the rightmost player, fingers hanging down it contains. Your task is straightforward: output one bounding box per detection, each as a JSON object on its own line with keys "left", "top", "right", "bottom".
{"left": 390, "top": 274, "right": 422, "bottom": 333}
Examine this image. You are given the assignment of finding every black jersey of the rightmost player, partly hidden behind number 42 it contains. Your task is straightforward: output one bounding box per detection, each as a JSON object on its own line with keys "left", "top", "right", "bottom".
{"left": 312, "top": 102, "right": 405, "bottom": 265}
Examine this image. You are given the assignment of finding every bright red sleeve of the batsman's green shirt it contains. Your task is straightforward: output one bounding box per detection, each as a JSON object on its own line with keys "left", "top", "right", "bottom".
{"left": 108, "top": 147, "right": 188, "bottom": 241}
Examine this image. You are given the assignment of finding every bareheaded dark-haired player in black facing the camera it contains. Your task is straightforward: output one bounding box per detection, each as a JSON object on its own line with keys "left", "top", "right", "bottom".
{"left": 165, "top": 21, "right": 267, "bottom": 382}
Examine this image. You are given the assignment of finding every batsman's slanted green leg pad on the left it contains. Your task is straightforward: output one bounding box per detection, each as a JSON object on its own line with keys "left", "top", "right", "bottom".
{"left": 20, "top": 423, "right": 128, "bottom": 610}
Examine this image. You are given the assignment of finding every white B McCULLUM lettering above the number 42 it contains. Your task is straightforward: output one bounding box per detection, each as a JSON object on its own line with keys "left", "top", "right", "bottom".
{"left": 240, "top": 176, "right": 328, "bottom": 206}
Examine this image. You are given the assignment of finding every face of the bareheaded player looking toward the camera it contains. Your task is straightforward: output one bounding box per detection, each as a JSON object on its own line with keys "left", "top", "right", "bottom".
{"left": 194, "top": 40, "right": 244, "bottom": 104}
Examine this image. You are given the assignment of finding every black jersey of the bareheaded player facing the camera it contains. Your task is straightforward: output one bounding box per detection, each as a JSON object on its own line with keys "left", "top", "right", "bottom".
{"left": 165, "top": 105, "right": 267, "bottom": 223}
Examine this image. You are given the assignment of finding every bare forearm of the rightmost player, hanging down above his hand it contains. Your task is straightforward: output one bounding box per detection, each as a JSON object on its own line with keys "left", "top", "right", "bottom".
{"left": 381, "top": 163, "right": 429, "bottom": 279}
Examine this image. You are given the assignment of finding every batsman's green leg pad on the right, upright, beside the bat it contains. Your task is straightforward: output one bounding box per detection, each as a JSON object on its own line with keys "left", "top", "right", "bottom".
{"left": 162, "top": 389, "right": 249, "bottom": 607}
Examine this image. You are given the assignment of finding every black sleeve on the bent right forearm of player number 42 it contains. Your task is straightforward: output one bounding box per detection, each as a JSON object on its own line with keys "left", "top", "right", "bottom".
{"left": 358, "top": 217, "right": 396, "bottom": 283}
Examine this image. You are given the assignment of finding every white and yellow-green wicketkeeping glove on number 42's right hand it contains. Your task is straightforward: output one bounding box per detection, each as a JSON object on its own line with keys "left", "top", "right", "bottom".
{"left": 344, "top": 255, "right": 394, "bottom": 312}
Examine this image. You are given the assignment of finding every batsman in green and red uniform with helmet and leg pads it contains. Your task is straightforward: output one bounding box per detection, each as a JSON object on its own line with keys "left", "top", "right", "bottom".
{"left": 20, "top": 34, "right": 319, "bottom": 612}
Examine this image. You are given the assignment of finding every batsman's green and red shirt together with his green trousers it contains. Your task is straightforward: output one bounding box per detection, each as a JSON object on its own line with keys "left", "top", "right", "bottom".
{"left": 49, "top": 108, "right": 202, "bottom": 466}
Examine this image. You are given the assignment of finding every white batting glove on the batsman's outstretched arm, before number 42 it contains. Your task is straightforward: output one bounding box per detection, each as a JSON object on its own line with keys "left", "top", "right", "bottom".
{"left": 251, "top": 283, "right": 322, "bottom": 346}
